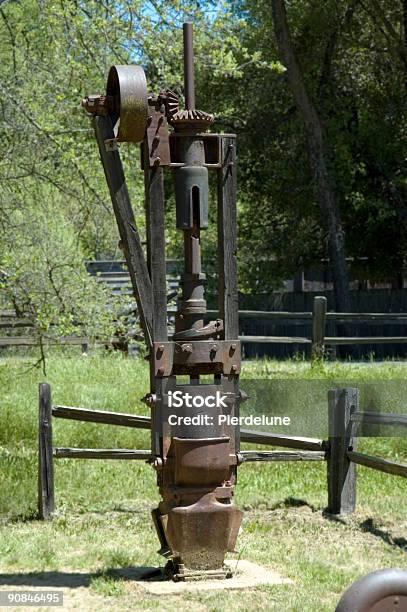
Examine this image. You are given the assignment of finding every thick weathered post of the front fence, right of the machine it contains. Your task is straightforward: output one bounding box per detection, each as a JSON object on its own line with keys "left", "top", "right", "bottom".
{"left": 328, "top": 388, "right": 359, "bottom": 514}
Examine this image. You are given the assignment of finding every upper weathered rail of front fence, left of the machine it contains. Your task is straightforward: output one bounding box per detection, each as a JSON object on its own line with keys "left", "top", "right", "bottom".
{"left": 52, "top": 406, "right": 151, "bottom": 429}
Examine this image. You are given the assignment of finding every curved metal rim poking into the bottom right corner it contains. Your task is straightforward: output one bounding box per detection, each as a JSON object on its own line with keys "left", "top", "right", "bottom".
{"left": 336, "top": 569, "right": 407, "bottom": 612}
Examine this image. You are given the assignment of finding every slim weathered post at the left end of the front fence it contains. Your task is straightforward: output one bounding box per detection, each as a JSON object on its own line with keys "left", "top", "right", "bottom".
{"left": 38, "top": 383, "right": 55, "bottom": 519}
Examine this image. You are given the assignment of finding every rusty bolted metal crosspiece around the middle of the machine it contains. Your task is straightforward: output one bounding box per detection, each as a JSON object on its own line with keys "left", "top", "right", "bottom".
{"left": 153, "top": 340, "right": 241, "bottom": 377}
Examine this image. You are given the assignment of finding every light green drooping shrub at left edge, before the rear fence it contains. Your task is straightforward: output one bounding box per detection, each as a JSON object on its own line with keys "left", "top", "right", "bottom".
{"left": 0, "top": 194, "right": 119, "bottom": 352}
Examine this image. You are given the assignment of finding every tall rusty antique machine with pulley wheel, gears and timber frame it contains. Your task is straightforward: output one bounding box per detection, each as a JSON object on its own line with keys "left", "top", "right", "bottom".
{"left": 83, "top": 24, "right": 242, "bottom": 580}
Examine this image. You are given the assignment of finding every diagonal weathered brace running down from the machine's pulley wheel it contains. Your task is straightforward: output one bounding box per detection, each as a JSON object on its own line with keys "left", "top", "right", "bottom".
{"left": 93, "top": 116, "right": 153, "bottom": 348}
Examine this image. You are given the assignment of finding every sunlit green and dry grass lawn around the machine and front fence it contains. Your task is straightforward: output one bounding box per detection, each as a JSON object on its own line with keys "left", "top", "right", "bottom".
{"left": 0, "top": 350, "right": 407, "bottom": 612}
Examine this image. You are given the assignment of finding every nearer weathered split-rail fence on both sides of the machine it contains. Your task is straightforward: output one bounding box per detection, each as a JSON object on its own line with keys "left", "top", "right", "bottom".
{"left": 38, "top": 383, "right": 407, "bottom": 519}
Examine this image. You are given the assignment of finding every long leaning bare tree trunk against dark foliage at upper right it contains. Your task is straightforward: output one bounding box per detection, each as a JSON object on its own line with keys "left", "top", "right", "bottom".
{"left": 271, "top": 0, "right": 350, "bottom": 312}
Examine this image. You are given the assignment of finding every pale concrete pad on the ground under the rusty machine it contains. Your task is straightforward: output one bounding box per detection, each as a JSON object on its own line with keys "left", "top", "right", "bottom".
{"left": 136, "top": 560, "right": 293, "bottom": 595}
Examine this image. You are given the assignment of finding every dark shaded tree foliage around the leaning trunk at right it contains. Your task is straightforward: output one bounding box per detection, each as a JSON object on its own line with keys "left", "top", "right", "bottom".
{"left": 224, "top": 0, "right": 407, "bottom": 298}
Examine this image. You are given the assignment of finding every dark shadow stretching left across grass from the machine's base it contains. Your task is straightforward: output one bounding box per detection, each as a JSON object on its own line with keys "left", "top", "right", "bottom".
{"left": 0, "top": 566, "right": 163, "bottom": 589}
